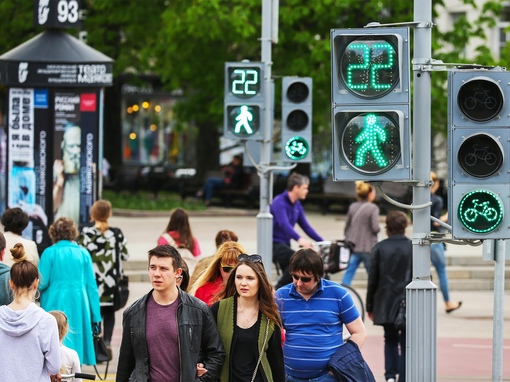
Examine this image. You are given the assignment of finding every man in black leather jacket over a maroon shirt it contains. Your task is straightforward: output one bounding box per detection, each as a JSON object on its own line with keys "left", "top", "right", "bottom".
{"left": 116, "top": 245, "right": 225, "bottom": 382}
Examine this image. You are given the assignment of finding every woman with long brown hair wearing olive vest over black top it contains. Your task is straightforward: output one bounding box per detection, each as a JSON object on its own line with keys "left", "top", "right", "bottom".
{"left": 211, "top": 254, "right": 285, "bottom": 382}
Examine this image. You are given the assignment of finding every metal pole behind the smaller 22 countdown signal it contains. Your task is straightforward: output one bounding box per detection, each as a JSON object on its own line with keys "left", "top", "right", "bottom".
{"left": 257, "top": 0, "right": 273, "bottom": 282}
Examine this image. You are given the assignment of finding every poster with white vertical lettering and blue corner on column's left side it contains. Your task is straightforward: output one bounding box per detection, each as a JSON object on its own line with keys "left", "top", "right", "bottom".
{"left": 7, "top": 88, "right": 51, "bottom": 253}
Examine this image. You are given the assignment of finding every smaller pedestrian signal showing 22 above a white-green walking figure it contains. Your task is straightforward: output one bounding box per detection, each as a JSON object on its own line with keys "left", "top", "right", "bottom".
{"left": 224, "top": 62, "right": 264, "bottom": 140}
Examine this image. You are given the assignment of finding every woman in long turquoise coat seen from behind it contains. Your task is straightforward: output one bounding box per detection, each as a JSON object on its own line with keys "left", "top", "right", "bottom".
{"left": 39, "top": 217, "right": 101, "bottom": 365}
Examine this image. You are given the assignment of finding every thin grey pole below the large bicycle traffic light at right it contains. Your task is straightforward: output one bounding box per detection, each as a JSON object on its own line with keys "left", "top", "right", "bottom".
{"left": 492, "top": 240, "right": 506, "bottom": 381}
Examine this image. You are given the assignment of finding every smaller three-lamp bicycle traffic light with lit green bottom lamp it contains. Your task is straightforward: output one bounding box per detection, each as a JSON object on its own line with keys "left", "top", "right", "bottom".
{"left": 282, "top": 77, "right": 312, "bottom": 163}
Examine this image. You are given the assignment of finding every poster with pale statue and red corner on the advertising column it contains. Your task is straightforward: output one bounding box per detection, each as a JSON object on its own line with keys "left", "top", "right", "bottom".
{"left": 53, "top": 91, "right": 98, "bottom": 227}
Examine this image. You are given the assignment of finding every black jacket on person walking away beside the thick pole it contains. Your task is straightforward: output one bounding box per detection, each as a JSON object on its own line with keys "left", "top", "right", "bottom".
{"left": 366, "top": 235, "right": 413, "bottom": 325}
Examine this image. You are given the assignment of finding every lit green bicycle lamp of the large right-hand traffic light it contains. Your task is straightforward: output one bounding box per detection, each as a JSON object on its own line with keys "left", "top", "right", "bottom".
{"left": 457, "top": 190, "right": 504, "bottom": 233}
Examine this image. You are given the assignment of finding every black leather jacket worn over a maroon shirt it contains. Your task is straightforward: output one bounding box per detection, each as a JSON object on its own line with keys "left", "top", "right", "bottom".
{"left": 117, "top": 289, "right": 225, "bottom": 382}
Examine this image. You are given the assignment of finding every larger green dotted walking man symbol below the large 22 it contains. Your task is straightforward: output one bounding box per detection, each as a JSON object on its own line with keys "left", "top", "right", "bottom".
{"left": 354, "top": 114, "right": 388, "bottom": 167}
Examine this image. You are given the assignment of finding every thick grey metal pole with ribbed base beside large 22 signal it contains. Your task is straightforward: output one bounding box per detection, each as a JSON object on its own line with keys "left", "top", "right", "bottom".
{"left": 406, "top": 0, "right": 437, "bottom": 382}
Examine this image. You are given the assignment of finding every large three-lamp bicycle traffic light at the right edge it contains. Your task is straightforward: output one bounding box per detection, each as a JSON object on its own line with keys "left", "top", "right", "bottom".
{"left": 448, "top": 68, "right": 510, "bottom": 239}
